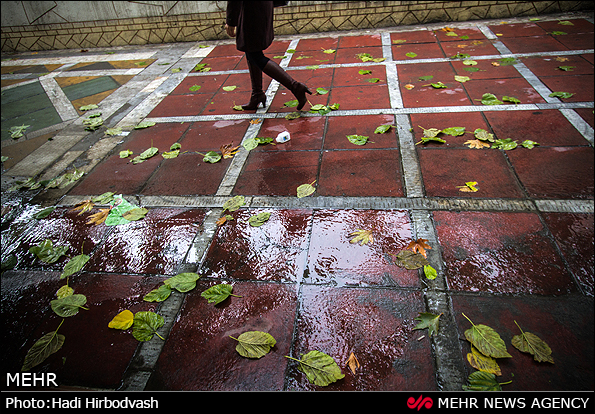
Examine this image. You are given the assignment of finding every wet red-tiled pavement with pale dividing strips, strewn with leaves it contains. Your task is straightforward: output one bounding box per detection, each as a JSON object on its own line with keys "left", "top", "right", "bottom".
{"left": 2, "top": 14, "right": 595, "bottom": 391}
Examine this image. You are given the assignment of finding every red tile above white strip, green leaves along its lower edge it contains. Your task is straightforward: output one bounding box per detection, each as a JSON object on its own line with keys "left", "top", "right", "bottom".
{"left": 463, "top": 78, "right": 545, "bottom": 105}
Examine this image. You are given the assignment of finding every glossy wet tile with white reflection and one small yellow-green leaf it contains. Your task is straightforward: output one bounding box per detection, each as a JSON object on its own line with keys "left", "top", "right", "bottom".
{"left": 304, "top": 210, "right": 419, "bottom": 287}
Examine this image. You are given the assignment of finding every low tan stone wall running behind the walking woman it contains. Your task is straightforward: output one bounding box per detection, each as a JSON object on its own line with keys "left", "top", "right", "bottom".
{"left": 1, "top": 1, "right": 593, "bottom": 52}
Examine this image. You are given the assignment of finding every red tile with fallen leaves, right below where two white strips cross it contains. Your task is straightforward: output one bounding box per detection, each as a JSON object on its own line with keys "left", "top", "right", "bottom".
{"left": 410, "top": 112, "right": 492, "bottom": 148}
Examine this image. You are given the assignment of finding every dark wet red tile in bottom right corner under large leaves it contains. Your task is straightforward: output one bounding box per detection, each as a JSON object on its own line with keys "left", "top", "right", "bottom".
{"left": 452, "top": 295, "right": 594, "bottom": 392}
